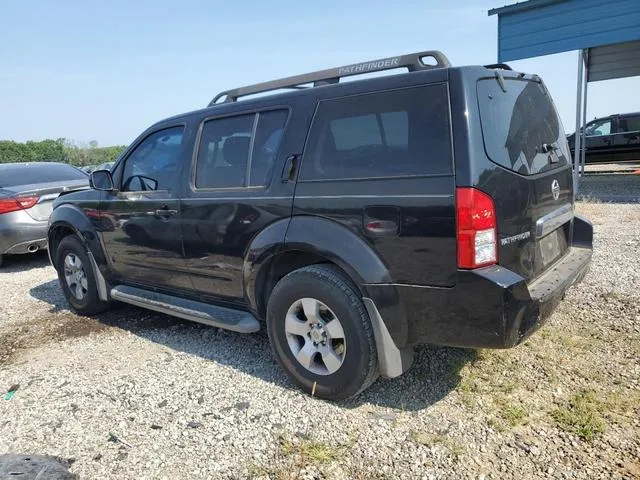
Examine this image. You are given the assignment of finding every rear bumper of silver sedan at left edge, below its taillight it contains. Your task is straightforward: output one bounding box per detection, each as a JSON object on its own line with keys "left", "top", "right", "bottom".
{"left": 0, "top": 211, "right": 47, "bottom": 255}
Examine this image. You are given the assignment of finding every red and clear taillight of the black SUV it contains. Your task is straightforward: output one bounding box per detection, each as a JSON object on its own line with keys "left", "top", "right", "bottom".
{"left": 456, "top": 187, "right": 498, "bottom": 268}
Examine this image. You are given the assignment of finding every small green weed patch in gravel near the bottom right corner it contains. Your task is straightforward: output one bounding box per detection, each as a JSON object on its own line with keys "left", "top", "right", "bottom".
{"left": 550, "top": 390, "right": 605, "bottom": 441}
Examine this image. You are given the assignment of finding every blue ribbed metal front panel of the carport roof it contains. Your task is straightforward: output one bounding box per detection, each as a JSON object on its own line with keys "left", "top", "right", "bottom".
{"left": 489, "top": 0, "right": 640, "bottom": 62}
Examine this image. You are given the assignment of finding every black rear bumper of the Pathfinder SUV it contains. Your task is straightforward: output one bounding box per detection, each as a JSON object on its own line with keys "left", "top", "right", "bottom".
{"left": 367, "top": 217, "right": 593, "bottom": 349}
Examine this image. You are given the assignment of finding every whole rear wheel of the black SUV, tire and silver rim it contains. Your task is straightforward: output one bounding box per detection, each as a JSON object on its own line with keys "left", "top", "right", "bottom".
{"left": 267, "top": 265, "right": 378, "bottom": 400}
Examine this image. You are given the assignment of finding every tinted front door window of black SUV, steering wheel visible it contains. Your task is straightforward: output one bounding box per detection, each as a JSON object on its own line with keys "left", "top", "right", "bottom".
{"left": 122, "top": 127, "right": 183, "bottom": 192}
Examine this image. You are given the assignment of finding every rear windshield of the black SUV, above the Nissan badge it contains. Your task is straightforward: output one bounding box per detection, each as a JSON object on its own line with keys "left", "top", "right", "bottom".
{"left": 477, "top": 78, "right": 570, "bottom": 175}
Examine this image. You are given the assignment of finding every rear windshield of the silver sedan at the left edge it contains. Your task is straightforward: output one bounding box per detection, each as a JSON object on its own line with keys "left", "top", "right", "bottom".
{"left": 0, "top": 163, "right": 89, "bottom": 188}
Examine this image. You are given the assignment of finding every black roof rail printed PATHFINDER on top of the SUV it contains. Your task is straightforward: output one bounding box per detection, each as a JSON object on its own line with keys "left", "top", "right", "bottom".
{"left": 209, "top": 50, "right": 451, "bottom": 107}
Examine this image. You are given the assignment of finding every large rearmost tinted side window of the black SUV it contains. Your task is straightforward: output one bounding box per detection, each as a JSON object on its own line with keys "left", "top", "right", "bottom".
{"left": 300, "top": 84, "right": 453, "bottom": 181}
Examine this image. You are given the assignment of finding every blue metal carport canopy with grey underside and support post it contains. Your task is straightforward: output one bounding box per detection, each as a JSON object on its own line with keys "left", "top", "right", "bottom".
{"left": 489, "top": 0, "right": 640, "bottom": 189}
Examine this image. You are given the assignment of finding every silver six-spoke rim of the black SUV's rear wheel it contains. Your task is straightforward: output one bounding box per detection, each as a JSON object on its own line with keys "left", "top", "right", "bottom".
{"left": 284, "top": 298, "right": 347, "bottom": 375}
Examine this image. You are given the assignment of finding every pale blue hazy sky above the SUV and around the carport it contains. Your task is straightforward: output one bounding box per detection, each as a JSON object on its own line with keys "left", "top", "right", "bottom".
{"left": 0, "top": 0, "right": 640, "bottom": 146}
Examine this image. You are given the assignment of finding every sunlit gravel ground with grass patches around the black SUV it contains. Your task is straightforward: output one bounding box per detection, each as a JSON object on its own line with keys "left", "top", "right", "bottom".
{"left": 0, "top": 203, "right": 640, "bottom": 479}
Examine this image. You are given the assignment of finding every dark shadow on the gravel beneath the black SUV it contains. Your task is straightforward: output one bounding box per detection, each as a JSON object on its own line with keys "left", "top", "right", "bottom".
{"left": 30, "top": 280, "right": 478, "bottom": 411}
